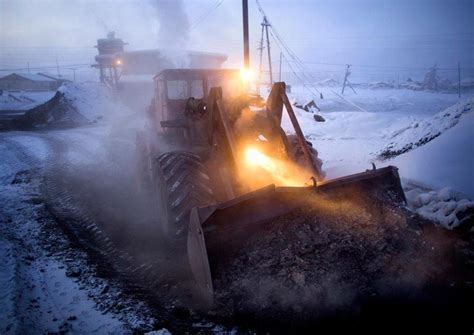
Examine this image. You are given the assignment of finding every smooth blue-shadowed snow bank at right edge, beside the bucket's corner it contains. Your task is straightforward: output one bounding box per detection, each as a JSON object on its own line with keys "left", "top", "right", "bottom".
{"left": 389, "top": 111, "right": 474, "bottom": 228}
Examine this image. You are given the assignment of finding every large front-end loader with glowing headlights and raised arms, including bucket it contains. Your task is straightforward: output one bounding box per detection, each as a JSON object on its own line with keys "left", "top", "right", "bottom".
{"left": 137, "top": 69, "right": 406, "bottom": 306}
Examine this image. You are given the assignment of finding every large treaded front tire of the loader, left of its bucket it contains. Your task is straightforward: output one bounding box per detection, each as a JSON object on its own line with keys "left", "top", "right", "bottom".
{"left": 153, "top": 151, "right": 214, "bottom": 240}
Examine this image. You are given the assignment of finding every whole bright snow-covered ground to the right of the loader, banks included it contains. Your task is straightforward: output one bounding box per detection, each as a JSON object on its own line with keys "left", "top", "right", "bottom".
{"left": 283, "top": 87, "right": 474, "bottom": 228}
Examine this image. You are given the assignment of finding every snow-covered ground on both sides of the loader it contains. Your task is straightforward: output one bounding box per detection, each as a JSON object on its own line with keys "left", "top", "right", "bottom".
{"left": 0, "top": 83, "right": 474, "bottom": 334}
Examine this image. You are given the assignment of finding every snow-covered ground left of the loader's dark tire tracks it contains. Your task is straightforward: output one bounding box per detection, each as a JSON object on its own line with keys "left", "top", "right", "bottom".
{"left": 0, "top": 127, "right": 159, "bottom": 334}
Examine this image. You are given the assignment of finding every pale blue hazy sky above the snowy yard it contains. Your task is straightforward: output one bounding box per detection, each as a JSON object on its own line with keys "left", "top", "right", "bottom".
{"left": 0, "top": 0, "right": 474, "bottom": 79}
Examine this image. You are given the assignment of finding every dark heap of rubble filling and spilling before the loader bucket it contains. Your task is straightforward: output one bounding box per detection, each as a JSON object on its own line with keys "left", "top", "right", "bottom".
{"left": 214, "top": 198, "right": 472, "bottom": 332}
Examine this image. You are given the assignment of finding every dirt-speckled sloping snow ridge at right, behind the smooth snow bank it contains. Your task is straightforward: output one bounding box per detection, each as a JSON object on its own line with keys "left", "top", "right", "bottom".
{"left": 381, "top": 97, "right": 474, "bottom": 158}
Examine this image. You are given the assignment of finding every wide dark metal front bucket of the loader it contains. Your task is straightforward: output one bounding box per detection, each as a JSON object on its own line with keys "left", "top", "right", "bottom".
{"left": 187, "top": 166, "right": 405, "bottom": 306}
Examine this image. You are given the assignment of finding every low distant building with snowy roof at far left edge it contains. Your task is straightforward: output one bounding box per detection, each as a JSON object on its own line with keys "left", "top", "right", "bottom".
{"left": 0, "top": 73, "right": 62, "bottom": 91}
